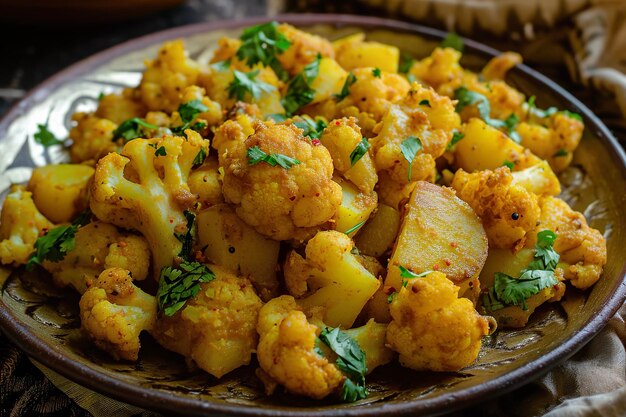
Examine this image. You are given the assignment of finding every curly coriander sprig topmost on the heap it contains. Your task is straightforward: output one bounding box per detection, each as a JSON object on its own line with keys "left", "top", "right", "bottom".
{"left": 237, "top": 22, "right": 291, "bottom": 81}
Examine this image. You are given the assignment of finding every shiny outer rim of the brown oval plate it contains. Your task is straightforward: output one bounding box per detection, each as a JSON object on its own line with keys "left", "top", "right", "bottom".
{"left": 0, "top": 14, "right": 626, "bottom": 417}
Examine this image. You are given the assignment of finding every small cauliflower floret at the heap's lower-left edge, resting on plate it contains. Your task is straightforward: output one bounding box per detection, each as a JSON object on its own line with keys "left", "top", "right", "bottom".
{"left": 80, "top": 268, "right": 157, "bottom": 361}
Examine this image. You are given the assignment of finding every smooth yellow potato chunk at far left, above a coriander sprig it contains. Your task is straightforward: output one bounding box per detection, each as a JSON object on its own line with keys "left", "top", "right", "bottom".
{"left": 28, "top": 164, "right": 94, "bottom": 223}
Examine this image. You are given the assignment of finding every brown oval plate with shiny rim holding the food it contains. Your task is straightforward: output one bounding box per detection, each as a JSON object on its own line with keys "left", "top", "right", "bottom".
{"left": 0, "top": 15, "right": 626, "bottom": 417}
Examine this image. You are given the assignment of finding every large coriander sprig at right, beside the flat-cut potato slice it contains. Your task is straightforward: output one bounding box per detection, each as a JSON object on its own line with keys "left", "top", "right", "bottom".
{"left": 483, "top": 230, "right": 560, "bottom": 311}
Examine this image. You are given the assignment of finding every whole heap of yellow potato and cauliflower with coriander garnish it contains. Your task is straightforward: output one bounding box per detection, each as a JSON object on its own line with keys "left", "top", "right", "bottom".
{"left": 0, "top": 22, "right": 606, "bottom": 402}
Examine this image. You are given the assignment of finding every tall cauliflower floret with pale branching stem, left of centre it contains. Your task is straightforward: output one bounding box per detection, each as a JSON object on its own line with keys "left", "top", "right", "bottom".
{"left": 90, "top": 129, "right": 208, "bottom": 276}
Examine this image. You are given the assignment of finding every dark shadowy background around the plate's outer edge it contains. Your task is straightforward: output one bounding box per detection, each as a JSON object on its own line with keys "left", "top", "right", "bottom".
{"left": 0, "top": 0, "right": 626, "bottom": 417}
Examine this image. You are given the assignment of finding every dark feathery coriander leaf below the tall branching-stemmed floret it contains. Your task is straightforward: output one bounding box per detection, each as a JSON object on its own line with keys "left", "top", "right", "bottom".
{"left": 157, "top": 261, "right": 215, "bottom": 316}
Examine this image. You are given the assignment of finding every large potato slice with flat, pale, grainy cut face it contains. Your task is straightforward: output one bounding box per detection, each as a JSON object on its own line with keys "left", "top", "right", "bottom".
{"left": 385, "top": 181, "right": 487, "bottom": 294}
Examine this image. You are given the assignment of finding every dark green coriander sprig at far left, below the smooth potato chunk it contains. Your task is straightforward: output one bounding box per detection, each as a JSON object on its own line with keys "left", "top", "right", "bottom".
{"left": 26, "top": 209, "right": 91, "bottom": 269}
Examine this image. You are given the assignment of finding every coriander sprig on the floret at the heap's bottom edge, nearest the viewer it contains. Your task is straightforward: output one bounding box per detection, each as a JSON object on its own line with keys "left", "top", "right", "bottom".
{"left": 319, "top": 327, "right": 368, "bottom": 402}
